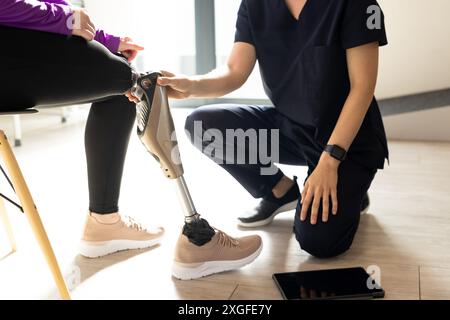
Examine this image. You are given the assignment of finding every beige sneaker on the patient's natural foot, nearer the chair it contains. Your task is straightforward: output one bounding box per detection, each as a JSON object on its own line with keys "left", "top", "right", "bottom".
{"left": 80, "top": 213, "right": 164, "bottom": 258}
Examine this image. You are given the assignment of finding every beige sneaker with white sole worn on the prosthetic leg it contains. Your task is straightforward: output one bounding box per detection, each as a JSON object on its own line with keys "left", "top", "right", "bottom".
{"left": 172, "top": 230, "right": 262, "bottom": 280}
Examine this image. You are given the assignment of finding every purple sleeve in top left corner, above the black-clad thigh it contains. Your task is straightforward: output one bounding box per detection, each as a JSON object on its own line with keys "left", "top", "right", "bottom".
{"left": 0, "top": 0, "right": 72, "bottom": 35}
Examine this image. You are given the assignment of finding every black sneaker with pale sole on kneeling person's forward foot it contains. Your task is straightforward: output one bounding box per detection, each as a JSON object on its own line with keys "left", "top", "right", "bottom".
{"left": 238, "top": 177, "right": 300, "bottom": 228}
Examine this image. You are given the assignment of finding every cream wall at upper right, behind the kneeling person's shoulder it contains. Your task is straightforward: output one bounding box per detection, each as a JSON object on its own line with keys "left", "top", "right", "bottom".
{"left": 377, "top": 0, "right": 450, "bottom": 98}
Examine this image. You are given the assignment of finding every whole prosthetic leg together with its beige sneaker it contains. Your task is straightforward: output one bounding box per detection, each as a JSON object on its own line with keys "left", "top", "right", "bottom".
{"left": 133, "top": 72, "right": 262, "bottom": 279}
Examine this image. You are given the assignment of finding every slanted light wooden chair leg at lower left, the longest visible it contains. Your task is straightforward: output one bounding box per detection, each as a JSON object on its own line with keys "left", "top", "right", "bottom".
{"left": 0, "top": 130, "right": 70, "bottom": 300}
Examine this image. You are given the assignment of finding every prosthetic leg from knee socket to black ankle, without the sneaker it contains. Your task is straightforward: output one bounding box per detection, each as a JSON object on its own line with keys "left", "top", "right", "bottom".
{"left": 133, "top": 72, "right": 215, "bottom": 246}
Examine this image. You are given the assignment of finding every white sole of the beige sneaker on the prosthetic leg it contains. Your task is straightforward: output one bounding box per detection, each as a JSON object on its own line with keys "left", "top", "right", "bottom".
{"left": 172, "top": 243, "right": 263, "bottom": 280}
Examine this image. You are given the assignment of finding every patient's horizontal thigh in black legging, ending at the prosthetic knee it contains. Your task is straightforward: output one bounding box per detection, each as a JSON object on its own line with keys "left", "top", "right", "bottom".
{"left": 0, "top": 26, "right": 136, "bottom": 110}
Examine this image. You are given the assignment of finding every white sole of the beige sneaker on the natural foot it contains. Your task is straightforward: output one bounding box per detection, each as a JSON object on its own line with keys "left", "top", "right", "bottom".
{"left": 79, "top": 236, "right": 163, "bottom": 258}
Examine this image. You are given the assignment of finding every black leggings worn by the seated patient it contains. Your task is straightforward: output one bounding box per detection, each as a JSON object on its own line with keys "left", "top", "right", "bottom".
{"left": 0, "top": 26, "right": 136, "bottom": 214}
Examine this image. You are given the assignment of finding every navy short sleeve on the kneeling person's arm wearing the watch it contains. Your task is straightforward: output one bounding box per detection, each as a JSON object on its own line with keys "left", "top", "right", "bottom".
{"left": 341, "top": 0, "right": 388, "bottom": 49}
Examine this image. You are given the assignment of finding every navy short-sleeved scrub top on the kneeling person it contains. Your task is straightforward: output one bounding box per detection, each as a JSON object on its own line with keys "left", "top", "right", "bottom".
{"left": 235, "top": 0, "right": 388, "bottom": 169}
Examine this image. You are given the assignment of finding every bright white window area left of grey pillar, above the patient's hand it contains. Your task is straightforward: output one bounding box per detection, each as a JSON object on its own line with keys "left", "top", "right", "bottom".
{"left": 85, "top": 0, "right": 195, "bottom": 72}
